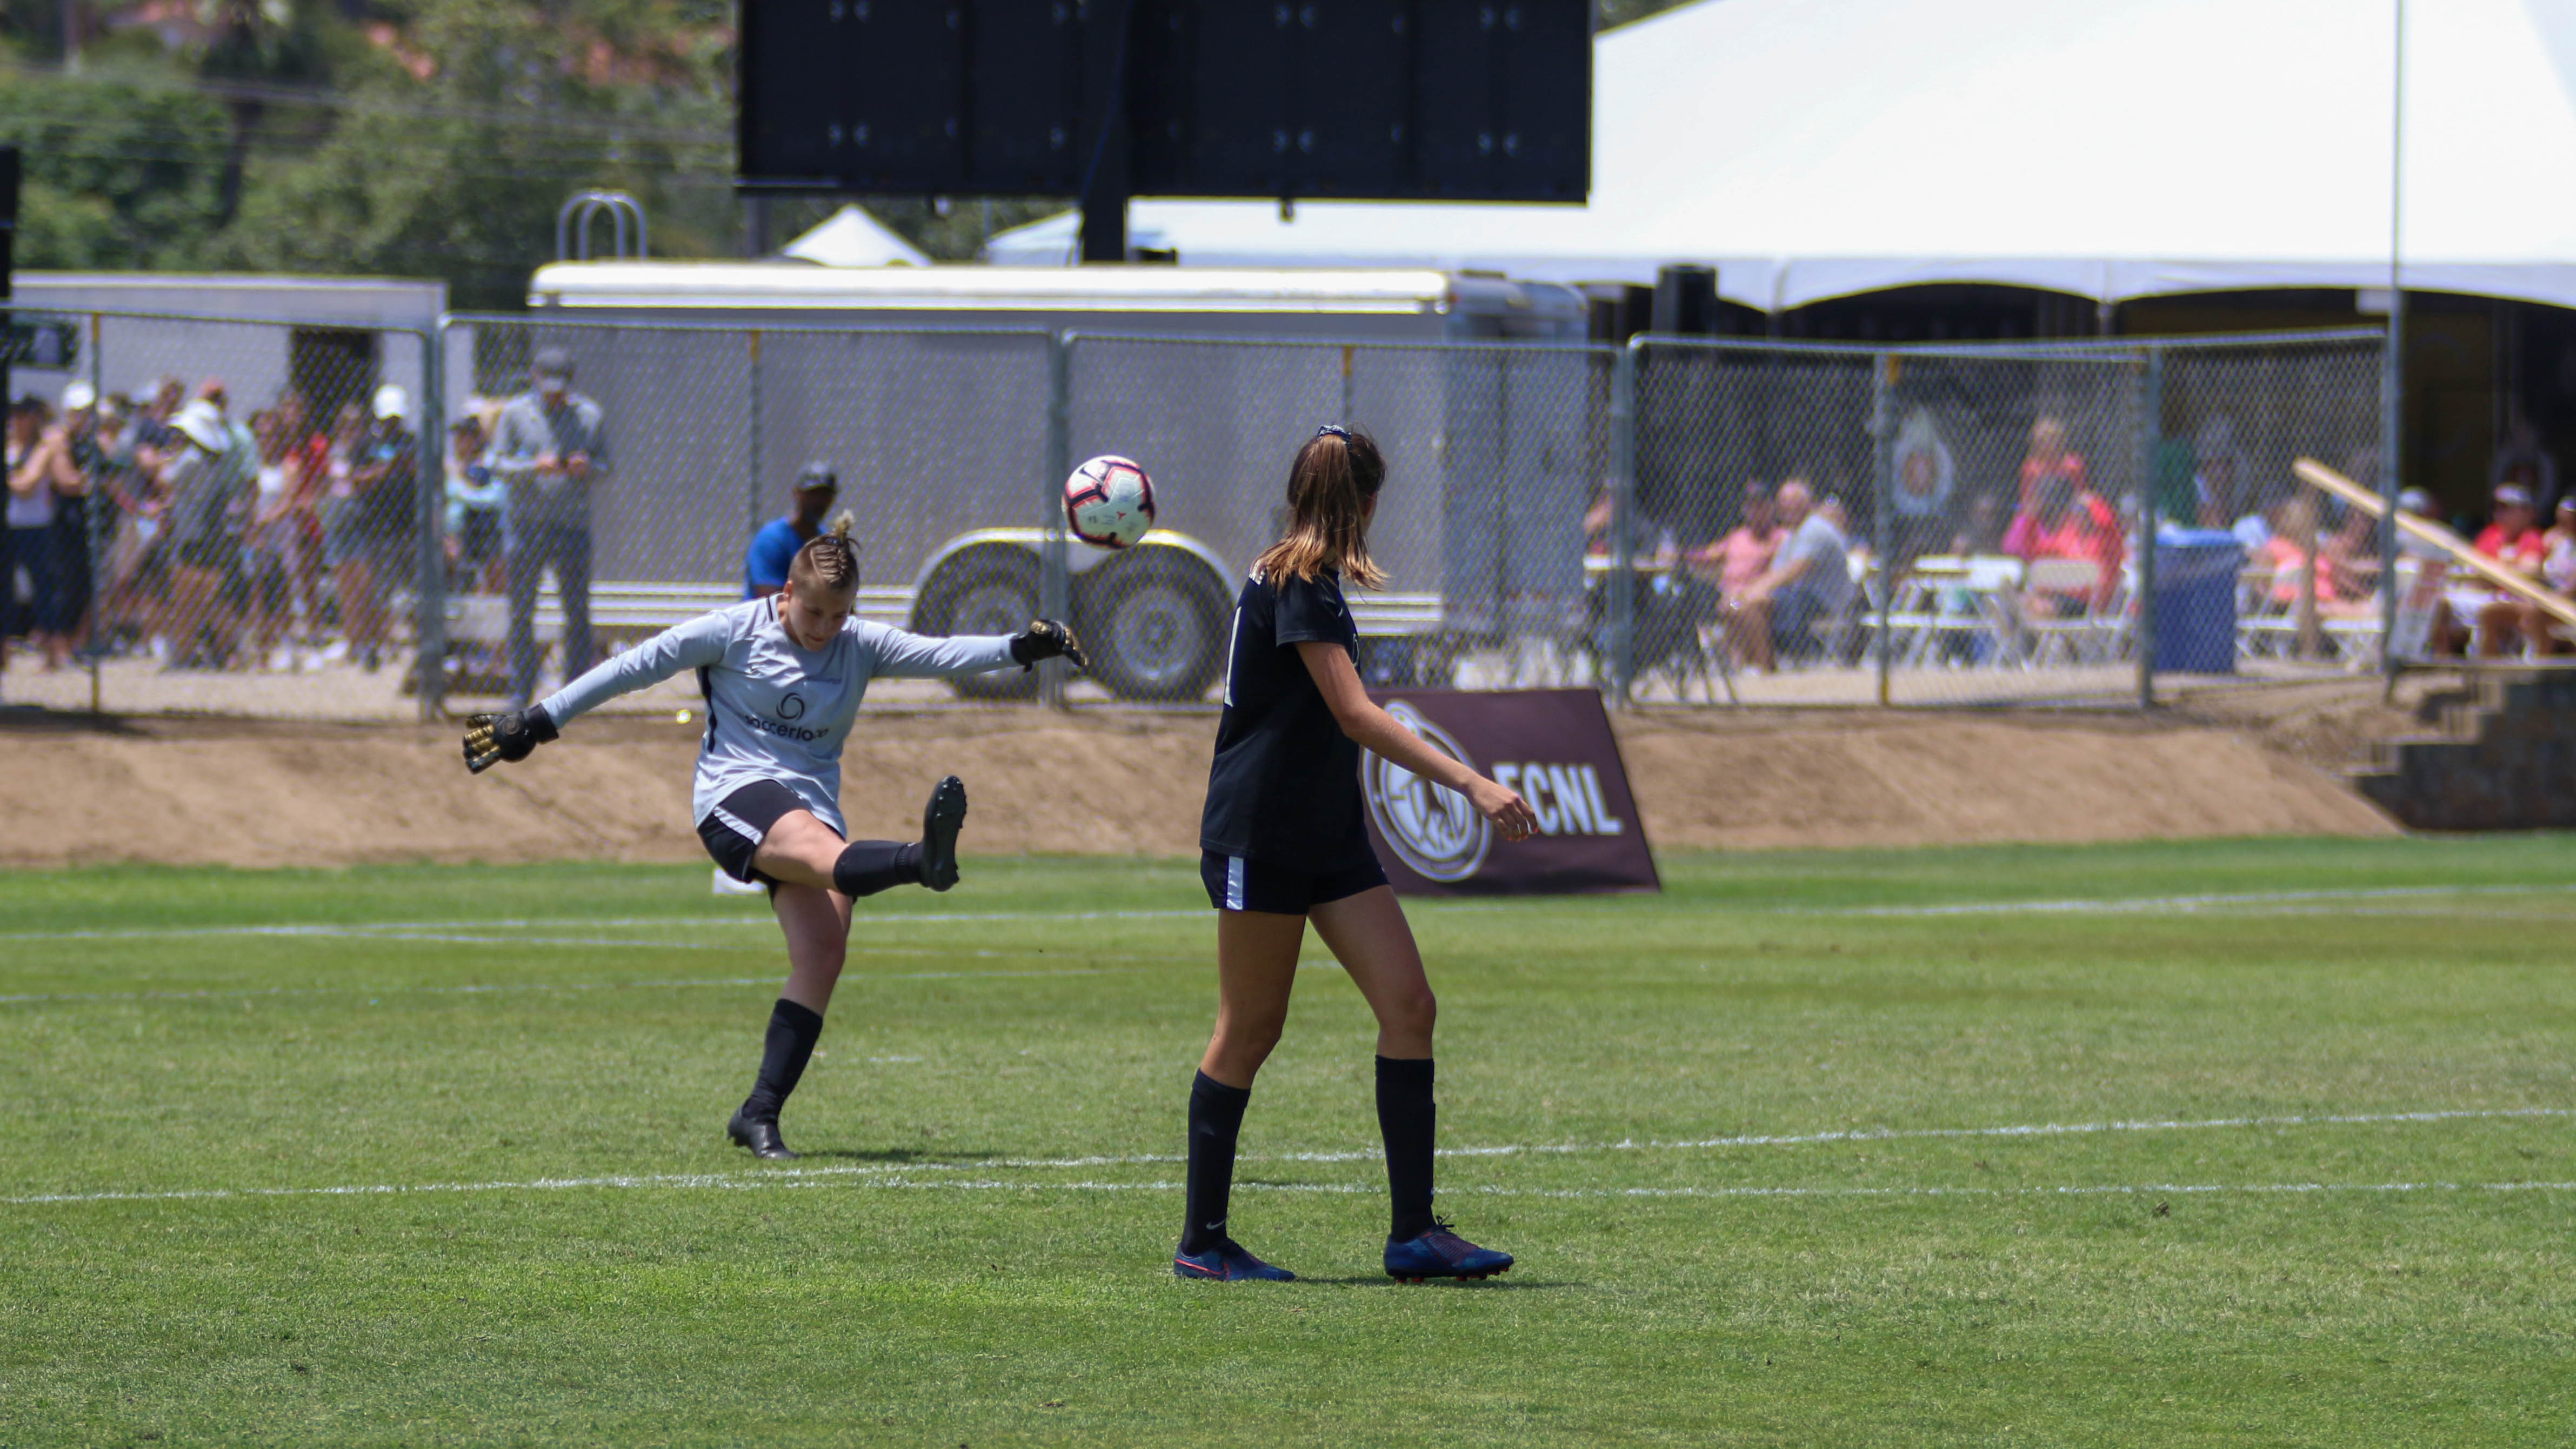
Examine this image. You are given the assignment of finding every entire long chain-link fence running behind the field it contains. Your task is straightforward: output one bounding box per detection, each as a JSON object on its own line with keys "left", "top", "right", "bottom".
{"left": 0, "top": 314, "right": 2390, "bottom": 720}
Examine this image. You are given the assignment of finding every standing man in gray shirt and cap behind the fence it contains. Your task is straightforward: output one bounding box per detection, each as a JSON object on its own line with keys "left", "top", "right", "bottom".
{"left": 490, "top": 348, "right": 608, "bottom": 708}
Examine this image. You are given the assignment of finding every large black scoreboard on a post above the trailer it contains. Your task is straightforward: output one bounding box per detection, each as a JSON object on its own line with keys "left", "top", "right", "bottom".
{"left": 739, "top": 0, "right": 1592, "bottom": 251}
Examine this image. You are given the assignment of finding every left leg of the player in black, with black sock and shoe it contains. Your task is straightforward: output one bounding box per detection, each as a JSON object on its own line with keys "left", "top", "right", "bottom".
{"left": 1172, "top": 911, "right": 1306, "bottom": 1279}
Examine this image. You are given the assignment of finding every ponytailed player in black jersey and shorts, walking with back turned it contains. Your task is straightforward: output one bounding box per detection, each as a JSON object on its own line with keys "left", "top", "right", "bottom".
{"left": 1172, "top": 427, "right": 1536, "bottom": 1281}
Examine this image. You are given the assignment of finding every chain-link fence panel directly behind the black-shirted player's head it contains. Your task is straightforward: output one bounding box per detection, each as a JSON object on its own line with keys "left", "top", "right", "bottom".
{"left": 1069, "top": 337, "right": 1618, "bottom": 700}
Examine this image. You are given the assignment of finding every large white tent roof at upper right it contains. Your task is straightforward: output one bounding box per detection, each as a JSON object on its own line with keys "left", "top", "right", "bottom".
{"left": 986, "top": 0, "right": 2576, "bottom": 309}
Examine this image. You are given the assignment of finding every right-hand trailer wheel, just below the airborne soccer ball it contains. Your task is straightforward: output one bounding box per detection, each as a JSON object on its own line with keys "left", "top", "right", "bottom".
{"left": 1082, "top": 548, "right": 1231, "bottom": 700}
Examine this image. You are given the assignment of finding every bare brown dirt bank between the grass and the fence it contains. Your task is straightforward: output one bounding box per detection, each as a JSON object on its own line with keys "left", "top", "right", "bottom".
{"left": 0, "top": 695, "right": 2395, "bottom": 865}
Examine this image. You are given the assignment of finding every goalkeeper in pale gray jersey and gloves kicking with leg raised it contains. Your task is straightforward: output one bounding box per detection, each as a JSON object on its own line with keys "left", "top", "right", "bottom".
{"left": 466, "top": 515, "right": 1087, "bottom": 1158}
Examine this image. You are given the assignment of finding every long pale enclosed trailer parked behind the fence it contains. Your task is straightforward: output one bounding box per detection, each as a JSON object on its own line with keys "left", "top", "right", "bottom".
{"left": 486, "top": 263, "right": 1597, "bottom": 700}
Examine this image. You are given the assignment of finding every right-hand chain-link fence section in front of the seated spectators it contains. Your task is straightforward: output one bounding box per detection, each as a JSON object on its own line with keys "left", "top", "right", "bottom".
{"left": 1638, "top": 335, "right": 2383, "bottom": 705}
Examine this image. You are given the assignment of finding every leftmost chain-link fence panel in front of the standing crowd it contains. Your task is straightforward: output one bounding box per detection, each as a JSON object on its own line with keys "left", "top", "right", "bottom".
{"left": 0, "top": 311, "right": 443, "bottom": 720}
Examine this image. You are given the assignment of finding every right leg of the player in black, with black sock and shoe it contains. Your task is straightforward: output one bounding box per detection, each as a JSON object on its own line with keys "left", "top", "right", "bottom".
{"left": 1311, "top": 885, "right": 1512, "bottom": 1281}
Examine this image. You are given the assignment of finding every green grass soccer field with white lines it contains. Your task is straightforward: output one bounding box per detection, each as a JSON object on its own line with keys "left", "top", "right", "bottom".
{"left": 0, "top": 837, "right": 2576, "bottom": 1449}
